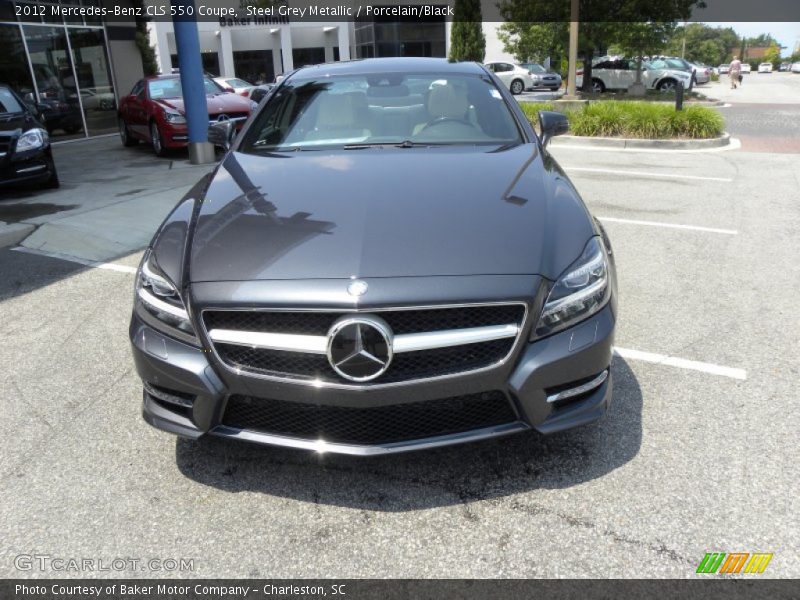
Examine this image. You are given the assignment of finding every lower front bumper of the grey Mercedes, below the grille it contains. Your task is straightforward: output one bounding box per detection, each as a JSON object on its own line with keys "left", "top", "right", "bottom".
{"left": 130, "top": 303, "right": 615, "bottom": 456}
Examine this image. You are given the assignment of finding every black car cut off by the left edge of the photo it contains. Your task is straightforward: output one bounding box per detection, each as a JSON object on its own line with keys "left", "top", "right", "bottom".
{"left": 0, "top": 83, "right": 59, "bottom": 188}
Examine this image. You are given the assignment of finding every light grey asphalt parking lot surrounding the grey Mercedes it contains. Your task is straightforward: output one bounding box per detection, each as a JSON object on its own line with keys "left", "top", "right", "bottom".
{"left": 0, "top": 76, "right": 800, "bottom": 578}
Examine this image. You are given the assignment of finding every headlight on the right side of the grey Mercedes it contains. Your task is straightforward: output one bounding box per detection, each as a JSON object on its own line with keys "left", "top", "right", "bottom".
{"left": 534, "top": 237, "right": 611, "bottom": 338}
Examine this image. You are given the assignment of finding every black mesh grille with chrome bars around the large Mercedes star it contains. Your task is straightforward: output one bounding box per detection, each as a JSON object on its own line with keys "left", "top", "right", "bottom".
{"left": 203, "top": 303, "right": 526, "bottom": 387}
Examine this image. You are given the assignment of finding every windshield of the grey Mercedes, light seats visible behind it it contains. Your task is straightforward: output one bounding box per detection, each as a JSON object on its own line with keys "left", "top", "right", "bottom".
{"left": 240, "top": 73, "right": 521, "bottom": 152}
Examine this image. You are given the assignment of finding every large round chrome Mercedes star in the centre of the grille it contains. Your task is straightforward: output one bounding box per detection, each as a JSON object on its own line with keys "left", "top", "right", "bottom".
{"left": 328, "top": 315, "right": 392, "bottom": 381}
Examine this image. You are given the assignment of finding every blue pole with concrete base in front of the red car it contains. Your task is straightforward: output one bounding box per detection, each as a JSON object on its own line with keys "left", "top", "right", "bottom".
{"left": 170, "top": 0, "right": 215, "bottom": 165}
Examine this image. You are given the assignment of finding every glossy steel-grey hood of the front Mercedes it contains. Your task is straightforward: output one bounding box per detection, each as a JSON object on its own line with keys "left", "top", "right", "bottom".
{"left": 185, "top": 144, "right": 594, "bottom": 282}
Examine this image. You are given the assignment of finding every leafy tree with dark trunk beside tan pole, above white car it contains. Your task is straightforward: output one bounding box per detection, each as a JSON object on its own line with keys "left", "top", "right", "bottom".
{"left": 498, "top": 0, "right": 704, "bottom": 91}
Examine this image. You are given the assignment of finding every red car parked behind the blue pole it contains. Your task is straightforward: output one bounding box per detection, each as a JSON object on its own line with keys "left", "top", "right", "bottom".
{"left": 119, "top": 75, "right": 251, "bottom": 156}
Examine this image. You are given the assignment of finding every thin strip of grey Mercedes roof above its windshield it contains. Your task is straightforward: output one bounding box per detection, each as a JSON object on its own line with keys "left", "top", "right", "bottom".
{"left": 293, "top": 57, "right": 485, "bottom": 77}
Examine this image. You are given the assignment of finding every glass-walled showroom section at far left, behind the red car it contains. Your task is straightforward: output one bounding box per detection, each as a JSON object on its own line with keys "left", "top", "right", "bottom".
{"left": 0, "top": 0, "right": 142, "bottom": 140}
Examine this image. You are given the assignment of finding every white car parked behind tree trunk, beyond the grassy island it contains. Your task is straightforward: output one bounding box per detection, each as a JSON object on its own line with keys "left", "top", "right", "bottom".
{"left": 575, "top": 58, "right": 692, "bottom": 93}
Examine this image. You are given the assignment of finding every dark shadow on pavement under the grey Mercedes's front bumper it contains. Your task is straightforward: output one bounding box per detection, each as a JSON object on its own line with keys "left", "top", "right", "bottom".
{"left": 175, "top": 357, "right": 642, "bottom": 511}
